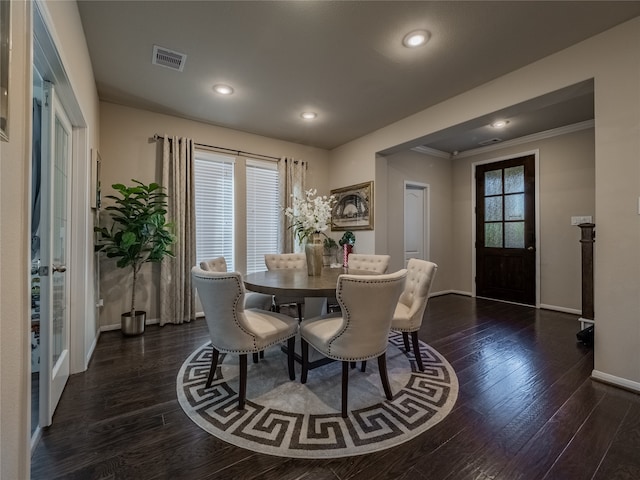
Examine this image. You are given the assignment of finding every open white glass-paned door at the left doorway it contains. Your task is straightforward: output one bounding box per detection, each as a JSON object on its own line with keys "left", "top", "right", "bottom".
{"left": 40, "top": 82, "right": 72, "bottom": 427}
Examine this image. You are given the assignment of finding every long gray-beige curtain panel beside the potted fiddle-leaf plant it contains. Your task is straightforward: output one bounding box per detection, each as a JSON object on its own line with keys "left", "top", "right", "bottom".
{"left": 160, "top": 135, "right": 196, "bottom": 325}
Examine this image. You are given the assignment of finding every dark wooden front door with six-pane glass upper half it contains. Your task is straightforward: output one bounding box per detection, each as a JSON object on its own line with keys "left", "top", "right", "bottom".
{"left": 476, "top": 155, "right": 536, "bottom": 305}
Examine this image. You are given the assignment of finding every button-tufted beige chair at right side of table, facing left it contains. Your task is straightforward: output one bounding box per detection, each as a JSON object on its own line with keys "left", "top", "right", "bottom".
{"left": 391, "top": 258, "right": 438, "bottom": 372}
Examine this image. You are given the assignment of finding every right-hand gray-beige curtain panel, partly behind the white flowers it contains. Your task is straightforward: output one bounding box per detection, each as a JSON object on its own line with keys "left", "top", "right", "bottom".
{"left": 278, "top": 157, "right": 307, "bottom": 253}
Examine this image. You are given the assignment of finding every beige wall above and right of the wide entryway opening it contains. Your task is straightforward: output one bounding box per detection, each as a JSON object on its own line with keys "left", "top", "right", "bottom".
{"left": 331, "top": 17, "right": 640, "bottom": 390}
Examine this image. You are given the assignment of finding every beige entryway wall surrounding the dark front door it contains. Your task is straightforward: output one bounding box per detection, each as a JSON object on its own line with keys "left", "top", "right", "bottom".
{"left": 452, "top": 128, "right": 595, "bottom": 313}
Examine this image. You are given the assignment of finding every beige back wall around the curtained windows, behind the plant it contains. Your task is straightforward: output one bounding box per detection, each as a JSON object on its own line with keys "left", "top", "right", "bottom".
{"left": 100, "top": 102, "right": 329, "bottom": 326}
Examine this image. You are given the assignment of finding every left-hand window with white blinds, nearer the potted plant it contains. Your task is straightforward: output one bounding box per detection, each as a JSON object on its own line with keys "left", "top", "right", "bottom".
{"left": 194, "top": 150, "right": 235, "bottom": 272}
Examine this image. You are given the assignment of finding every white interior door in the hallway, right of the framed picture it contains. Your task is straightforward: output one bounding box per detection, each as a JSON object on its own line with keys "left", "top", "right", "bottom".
{"left": 404, "top": 184, "right": 428, "bottom": 266}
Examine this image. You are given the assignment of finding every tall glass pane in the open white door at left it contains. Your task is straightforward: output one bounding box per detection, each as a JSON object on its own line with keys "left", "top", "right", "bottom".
{"left": 51, "top": 118, "right": 69, "bottom": 365}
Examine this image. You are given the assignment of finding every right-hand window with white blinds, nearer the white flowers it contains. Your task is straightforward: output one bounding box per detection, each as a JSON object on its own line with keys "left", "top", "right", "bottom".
{"left": 246, "top": 159, "right": 280, "bottom": 273}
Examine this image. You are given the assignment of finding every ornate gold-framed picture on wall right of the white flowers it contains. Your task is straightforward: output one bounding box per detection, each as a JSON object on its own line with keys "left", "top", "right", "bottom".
{"left": 331, "top": 181, "right": 373, "bottom": 230}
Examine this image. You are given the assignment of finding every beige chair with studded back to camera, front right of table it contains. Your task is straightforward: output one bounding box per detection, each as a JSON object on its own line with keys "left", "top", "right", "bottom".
{"left": 300, "top": 269, "right": 407, "bottom": 418}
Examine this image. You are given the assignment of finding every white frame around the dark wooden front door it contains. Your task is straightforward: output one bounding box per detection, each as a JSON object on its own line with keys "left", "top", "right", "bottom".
{"left": 471, "top": 149, "right": 540, "bottom": 308}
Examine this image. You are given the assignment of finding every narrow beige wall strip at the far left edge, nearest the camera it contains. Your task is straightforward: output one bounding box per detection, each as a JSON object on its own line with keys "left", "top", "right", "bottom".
{"left": 0, "top": 2, "right": 31, "bottom": 479}
